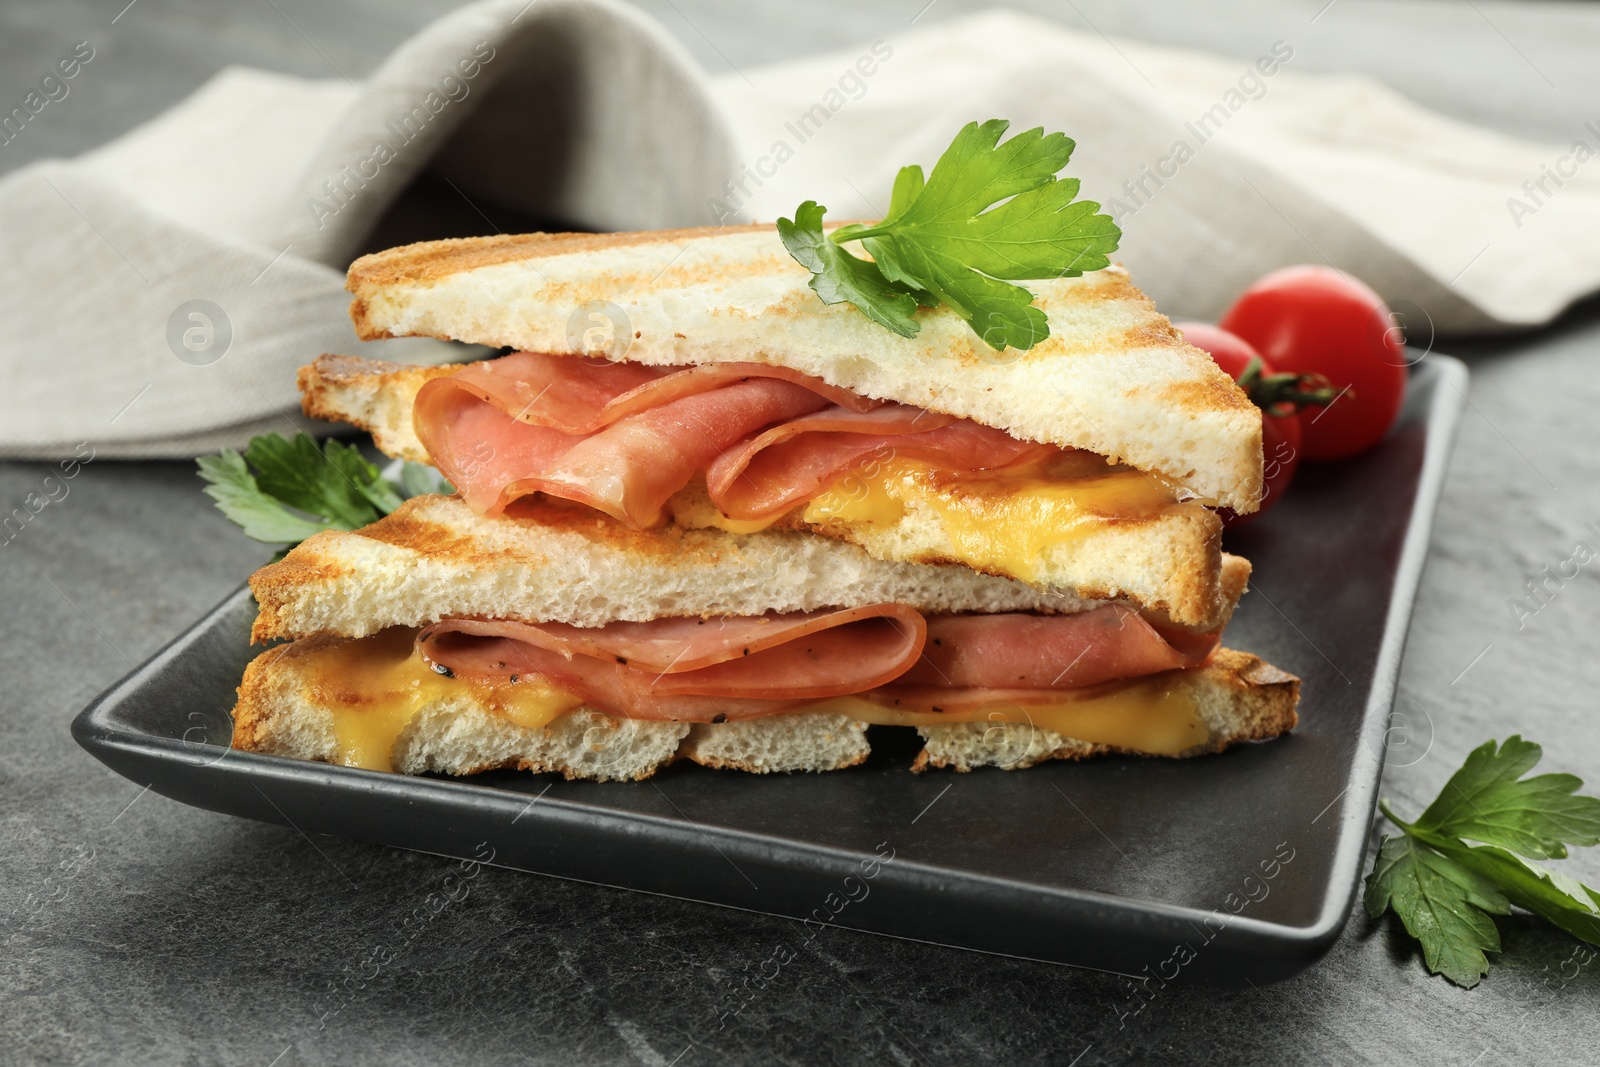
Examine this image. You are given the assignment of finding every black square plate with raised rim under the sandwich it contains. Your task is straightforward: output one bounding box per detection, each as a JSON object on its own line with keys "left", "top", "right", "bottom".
{"left": 72, "top": 355, "right": 1467, "bottom": 981}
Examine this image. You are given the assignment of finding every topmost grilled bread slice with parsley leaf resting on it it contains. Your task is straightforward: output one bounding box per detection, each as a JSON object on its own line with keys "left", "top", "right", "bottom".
{"left": 347, "top": 226, "right": 1261, "bottom": 512}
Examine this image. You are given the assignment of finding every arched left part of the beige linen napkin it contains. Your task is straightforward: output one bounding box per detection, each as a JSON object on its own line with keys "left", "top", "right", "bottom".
{"left": 0, "top": 0, "right": 733, "bottom": 458}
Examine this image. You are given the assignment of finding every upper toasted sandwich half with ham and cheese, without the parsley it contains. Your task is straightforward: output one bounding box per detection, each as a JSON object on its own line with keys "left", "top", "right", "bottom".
{"left": 299, "top": 226, "right": 1261, "bottom": 627}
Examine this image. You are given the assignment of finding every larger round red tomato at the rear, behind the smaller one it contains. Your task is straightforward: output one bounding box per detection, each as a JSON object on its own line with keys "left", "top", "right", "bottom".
{"left": 1221, "top": 266, "right": 1406, "bottom": 459}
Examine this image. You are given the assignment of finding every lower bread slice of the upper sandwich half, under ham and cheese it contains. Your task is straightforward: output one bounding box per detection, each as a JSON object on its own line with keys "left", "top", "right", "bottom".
{"left": 299, "top": 355, "right": 1221, "bottom": 625}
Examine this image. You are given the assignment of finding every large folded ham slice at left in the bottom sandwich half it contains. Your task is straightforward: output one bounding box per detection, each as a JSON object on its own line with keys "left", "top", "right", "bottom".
{"left": 416, "top": 605, "right": 926, "bottom": 721}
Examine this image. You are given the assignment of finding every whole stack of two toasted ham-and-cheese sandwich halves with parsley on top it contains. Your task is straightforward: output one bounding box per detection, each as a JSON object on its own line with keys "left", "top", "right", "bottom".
{"left": 222, "top": 120, "right": 1299, "bottom": 781}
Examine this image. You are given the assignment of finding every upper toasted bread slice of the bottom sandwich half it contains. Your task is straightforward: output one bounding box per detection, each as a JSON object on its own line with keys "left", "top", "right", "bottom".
{"left": 250, "top": 496, "right": 1250, "bottom": 641}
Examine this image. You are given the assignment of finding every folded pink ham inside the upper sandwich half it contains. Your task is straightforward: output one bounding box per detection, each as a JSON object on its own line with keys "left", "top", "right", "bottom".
{"left": 413, "top": 352, "right": 1062, "bottom": 528}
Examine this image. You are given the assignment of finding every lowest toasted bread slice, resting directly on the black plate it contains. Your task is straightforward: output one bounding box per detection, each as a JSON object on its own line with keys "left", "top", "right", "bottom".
{"left": 234, "top": 637, "right": 1299, "bottom": 781}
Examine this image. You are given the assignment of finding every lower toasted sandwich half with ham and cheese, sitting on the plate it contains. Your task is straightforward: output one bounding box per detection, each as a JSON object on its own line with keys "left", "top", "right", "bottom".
{"left": 234, "top": 496, "right": 1299, "bottom": 781}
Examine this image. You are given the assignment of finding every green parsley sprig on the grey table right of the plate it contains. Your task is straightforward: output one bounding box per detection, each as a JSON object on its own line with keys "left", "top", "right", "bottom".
{"left": 1366, "top": 734, "right": 1600, "bottom": 989}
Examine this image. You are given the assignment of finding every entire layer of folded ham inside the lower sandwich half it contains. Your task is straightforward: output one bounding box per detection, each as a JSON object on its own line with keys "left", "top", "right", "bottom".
{"left": 416, "top": 605, "right": 1221, "bottom": 721}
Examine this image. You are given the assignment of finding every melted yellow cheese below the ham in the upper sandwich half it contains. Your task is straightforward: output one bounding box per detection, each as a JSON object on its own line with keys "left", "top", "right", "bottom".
{"left": 803, "top": 461, "right": 1178, "bottom": 581}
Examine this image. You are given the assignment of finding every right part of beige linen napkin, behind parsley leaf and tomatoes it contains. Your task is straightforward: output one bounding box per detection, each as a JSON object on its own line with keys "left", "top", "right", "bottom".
{"left": 715, "top": 11, "right": 1600, "bottom": 336}
